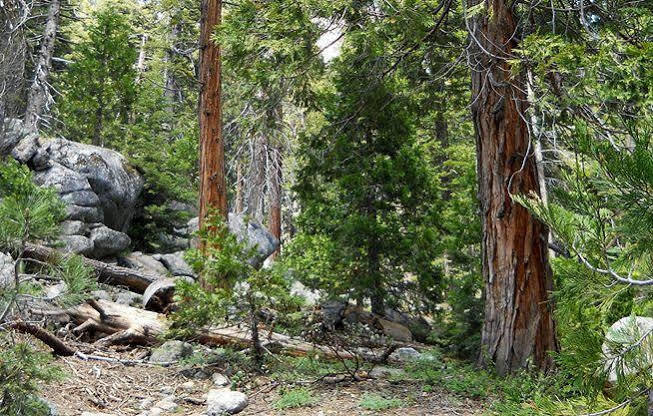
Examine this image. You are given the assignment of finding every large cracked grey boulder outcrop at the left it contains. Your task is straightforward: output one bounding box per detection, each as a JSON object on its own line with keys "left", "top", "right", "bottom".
{"left": 0, "top": 120, "right": 144, "bottom": 258}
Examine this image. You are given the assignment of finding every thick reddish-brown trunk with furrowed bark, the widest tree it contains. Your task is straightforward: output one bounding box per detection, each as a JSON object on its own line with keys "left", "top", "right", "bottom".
{"left": 468, "top": 0, "right": 557, "bottom": 375}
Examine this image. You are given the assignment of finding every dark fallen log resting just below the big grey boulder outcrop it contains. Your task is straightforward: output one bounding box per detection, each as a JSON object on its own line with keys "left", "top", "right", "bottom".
{"left": 23, "top": 243, "right": 166, "bottom": 294}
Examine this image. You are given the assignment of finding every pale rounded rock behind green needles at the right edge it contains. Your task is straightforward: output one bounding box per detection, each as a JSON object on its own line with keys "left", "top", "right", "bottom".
{"left": 602, "top": 316, "right": 653, "bottom": 383}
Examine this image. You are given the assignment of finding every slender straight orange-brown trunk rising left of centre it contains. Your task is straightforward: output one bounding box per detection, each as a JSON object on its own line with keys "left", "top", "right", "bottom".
{"left": 199, "top": 0, "right": 227, "bottom": 227}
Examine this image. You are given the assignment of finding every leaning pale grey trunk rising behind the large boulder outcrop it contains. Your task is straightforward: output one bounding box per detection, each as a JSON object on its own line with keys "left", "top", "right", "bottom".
{"left": 25, "top": 0, "right": 61, "bottom": 131}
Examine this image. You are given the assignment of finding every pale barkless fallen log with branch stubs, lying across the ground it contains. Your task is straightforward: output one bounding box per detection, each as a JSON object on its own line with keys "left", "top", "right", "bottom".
{"left": 44, "top": 300, "right": 354, "bottom": 359}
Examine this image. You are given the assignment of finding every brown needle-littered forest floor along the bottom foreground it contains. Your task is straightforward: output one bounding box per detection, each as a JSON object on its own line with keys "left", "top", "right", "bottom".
{"left": 35, "top": 349, "right": 485, "bottom": 416}
